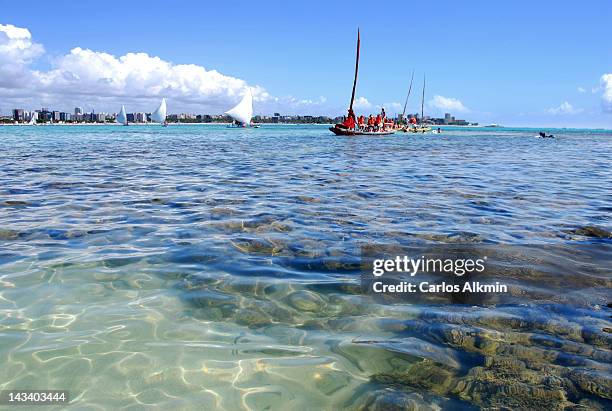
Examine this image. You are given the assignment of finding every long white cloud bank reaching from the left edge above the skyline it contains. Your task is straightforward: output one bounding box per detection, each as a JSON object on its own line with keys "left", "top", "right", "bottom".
{"left": 0, "top": 25, "right": 327, "bottom": 113}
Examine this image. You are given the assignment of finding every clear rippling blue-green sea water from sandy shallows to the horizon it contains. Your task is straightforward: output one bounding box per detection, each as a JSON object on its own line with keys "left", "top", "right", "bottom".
{"left": 0, "top": 125, "right": 612, "bottom": 410}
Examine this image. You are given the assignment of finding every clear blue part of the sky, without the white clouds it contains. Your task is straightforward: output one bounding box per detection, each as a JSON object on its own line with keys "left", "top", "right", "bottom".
{"left": 0, "top": 0, "right": 612, "bottom": 128}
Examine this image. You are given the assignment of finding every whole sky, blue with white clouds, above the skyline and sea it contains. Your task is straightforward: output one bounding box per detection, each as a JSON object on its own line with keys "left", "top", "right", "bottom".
{"left": 0, "top": 1, "right": 612, "bottom": 128}
